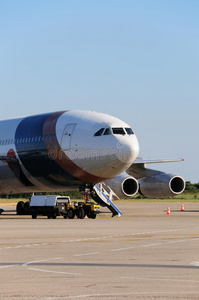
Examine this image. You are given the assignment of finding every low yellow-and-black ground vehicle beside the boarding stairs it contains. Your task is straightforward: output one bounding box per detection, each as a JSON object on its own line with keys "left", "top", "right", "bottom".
{"left": 67, "top": 202, "right": 100, "bottom": 219}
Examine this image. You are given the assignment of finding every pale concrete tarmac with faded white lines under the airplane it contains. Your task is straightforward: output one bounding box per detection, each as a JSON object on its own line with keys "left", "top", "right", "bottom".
{"left": 0, "top": 202, "right": 199, "bottom": 300}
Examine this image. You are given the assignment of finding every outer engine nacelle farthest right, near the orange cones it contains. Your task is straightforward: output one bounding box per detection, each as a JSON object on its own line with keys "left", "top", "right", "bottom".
{"left": 139, "top": 173, "right": 185, "bottom": 198}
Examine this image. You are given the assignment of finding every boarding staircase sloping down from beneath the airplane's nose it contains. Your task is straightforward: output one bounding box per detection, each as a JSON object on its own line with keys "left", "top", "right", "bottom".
{"left": 91, "top": 183, "right": 123, "bottom": 217}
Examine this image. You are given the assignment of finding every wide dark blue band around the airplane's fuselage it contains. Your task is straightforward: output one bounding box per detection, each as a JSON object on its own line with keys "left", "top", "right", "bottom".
{"left": 15, "top": 113, "right": 81, "bottom": 188}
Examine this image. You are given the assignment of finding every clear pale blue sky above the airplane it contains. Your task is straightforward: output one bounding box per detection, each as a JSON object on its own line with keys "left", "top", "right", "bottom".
{"left": 0, "top": 0, "right": 199, "bottom": 183}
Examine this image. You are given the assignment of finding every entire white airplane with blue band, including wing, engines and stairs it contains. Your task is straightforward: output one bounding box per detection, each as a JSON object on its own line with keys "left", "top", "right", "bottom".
{"left": 0, "top": 110, "right": 185, "bottom": 215}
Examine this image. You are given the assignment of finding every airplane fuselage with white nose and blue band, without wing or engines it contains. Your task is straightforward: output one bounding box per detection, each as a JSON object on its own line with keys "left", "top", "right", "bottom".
{"left": 0, "top": 111, "right": 139, "bottom": 193}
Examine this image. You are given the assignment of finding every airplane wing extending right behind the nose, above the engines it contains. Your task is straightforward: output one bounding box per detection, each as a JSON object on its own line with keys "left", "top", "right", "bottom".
{"left": 126, "top": 158, "right": 184, "bottom": 179}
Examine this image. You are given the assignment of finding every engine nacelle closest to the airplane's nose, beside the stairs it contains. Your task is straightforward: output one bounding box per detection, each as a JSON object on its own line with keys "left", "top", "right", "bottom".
{"left": 105, "top": 172, "right": 139, "bottom": 199}
